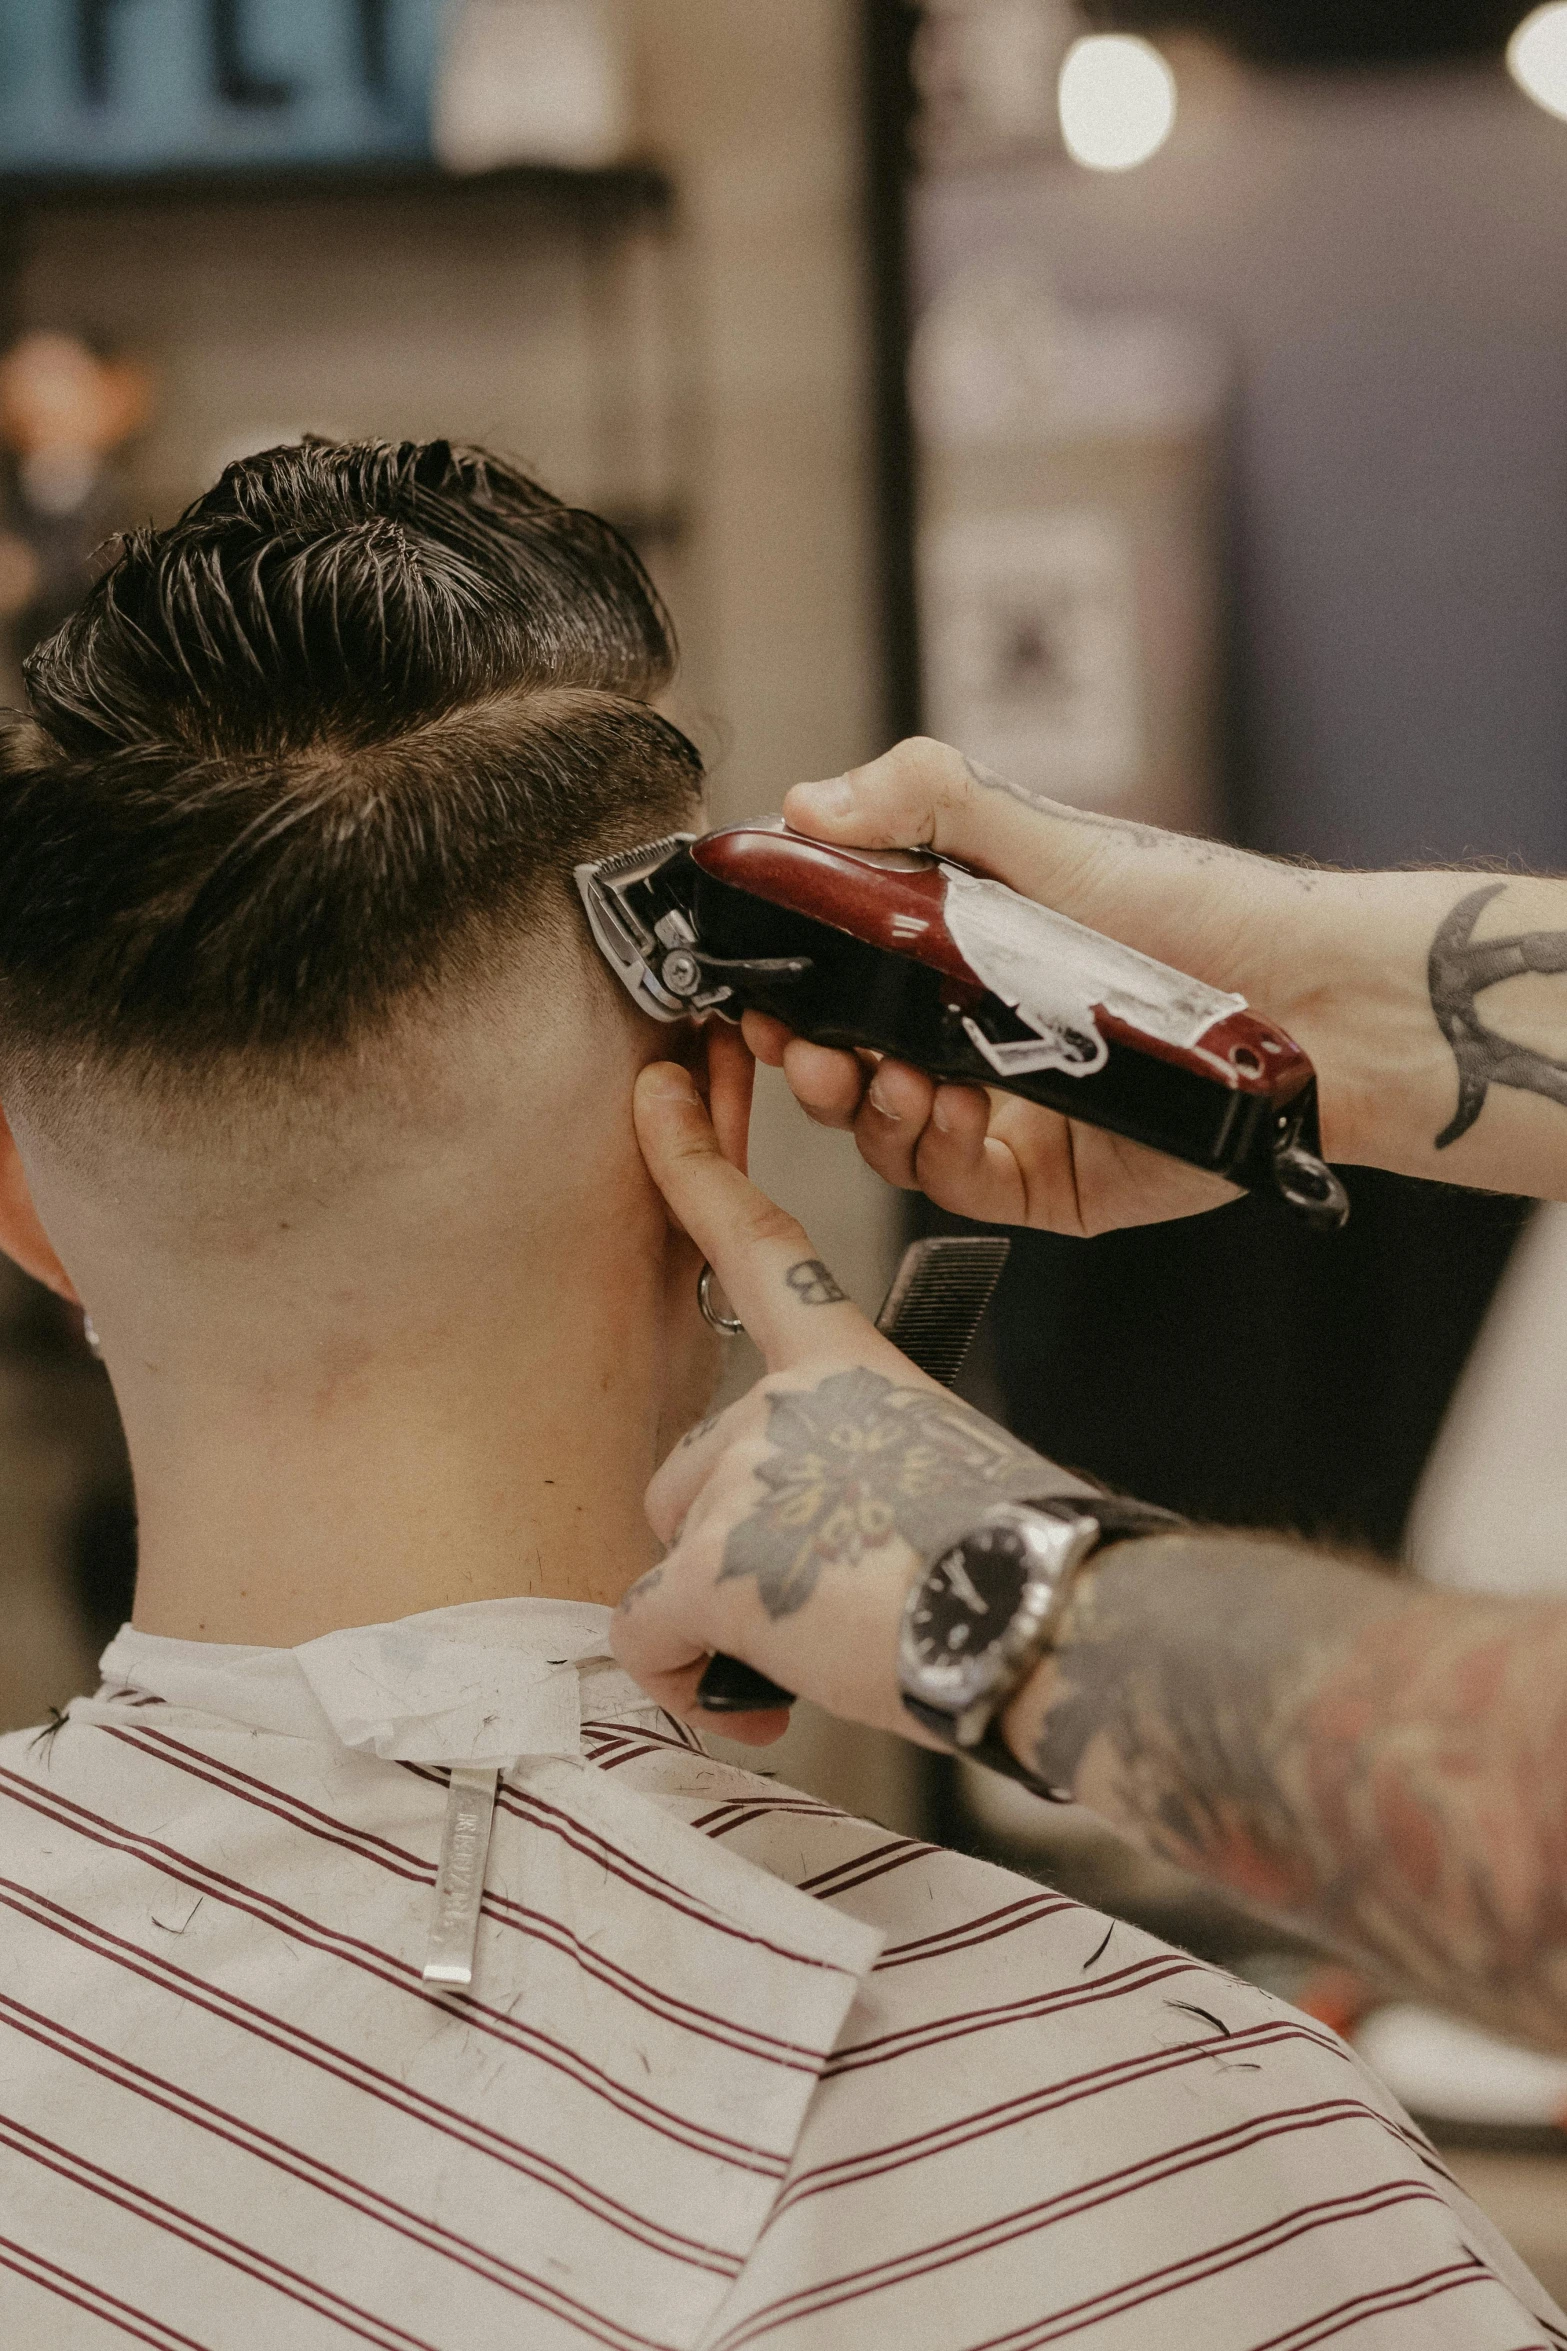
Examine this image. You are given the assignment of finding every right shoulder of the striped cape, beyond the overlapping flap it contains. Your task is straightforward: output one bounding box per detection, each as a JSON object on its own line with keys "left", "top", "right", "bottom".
{"left": 610, "top": 1733, "right": 1567, "bottom": 2351}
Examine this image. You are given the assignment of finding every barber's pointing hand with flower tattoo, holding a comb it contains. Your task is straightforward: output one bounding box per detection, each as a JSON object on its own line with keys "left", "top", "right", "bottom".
{"left": 611, "top": 1063, "right": 1083, "bottom": 1742}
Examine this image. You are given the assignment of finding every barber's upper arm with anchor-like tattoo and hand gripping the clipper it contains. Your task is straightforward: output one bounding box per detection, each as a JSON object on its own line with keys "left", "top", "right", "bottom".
{"left": 761, "top": 738, "right": 1567, "bottom": 1232}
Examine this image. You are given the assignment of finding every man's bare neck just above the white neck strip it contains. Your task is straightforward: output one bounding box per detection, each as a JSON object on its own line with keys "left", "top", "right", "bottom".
{"left": 117, "top": 1291, "right": 663, "bottom": 1648}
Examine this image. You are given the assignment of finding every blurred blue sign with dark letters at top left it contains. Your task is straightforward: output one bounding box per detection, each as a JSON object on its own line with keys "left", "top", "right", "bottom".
{"left": 0, "top": 0, "right": 444, "bottom": 172}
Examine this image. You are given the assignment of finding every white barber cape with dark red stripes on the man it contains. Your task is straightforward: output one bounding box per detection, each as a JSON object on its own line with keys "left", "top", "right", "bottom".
{"left": 0, "top": 1601, "right": 1567, "bottom": 2351}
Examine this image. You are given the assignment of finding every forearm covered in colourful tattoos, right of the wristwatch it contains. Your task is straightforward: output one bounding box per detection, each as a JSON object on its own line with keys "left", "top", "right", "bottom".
{"left": 1036, "top": 1535, "right": 1567, "bottom": 2045}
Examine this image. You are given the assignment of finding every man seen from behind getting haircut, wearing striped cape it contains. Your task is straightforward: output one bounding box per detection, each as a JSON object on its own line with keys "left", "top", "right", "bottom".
{"left": 0, "top": 442, "right": 1567, "bottom": 2351}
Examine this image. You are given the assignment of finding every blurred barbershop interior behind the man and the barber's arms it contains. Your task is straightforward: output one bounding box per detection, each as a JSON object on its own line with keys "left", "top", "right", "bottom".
{"left": 0, "top": 0, "right": 1567, "bottom": 2295}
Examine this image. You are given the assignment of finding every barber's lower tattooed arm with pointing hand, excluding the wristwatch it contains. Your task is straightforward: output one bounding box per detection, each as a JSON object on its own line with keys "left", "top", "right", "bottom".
{"left": 613, "top": 1063, "right": 1567, "bottom": 2048}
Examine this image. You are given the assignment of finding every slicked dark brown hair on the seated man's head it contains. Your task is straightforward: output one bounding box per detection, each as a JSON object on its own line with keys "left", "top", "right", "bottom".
{"left": 0, "top": 440, "right": 700, "bottom": 1070}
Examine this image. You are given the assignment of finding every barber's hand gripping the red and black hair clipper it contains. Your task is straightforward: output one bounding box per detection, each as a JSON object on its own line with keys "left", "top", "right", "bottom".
{"left": 745, "top": 738, "right": 1372, "bottom": 1234}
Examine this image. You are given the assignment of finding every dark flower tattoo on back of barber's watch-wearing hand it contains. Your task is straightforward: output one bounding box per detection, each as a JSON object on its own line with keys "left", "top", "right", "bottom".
{"left": 719, "top": 1364, "right": 1069, "bottom": 1617}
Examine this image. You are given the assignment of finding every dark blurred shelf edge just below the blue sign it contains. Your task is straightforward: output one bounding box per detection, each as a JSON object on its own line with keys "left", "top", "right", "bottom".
{"left": 0, "top": 162, "right": 674, "bottom": 226}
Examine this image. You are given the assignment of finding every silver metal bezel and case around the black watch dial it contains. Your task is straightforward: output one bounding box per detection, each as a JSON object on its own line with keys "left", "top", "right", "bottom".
{"left": 897, "top": 1502, "right": 1099, "bottom": 1747}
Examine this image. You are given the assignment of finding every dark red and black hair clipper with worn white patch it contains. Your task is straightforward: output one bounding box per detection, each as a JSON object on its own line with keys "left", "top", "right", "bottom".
{"left": 576, "top": 818, "right": 1349, "bottom": 1232}
